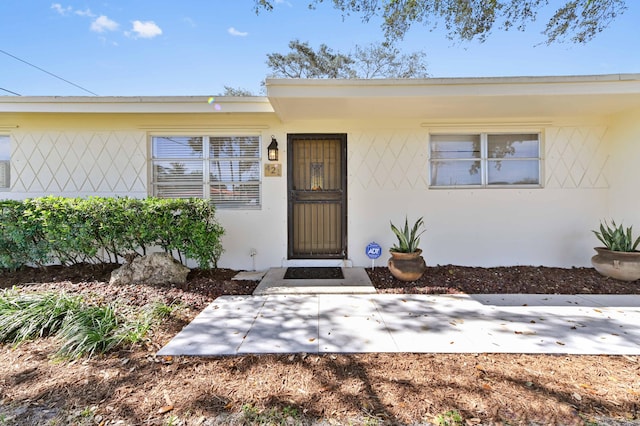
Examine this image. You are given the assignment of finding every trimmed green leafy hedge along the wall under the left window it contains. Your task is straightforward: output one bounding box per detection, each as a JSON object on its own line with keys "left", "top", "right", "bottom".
{"left": 0, "top": 196, "right": 224, "bottom": 270}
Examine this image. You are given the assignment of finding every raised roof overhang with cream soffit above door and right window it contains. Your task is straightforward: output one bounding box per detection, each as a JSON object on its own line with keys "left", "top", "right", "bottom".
{"left": 267, "top": 74, "right": 640, "bottom": 122}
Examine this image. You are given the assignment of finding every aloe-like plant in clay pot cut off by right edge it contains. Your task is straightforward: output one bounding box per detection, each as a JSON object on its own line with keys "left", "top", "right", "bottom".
{"left": 591, "top": 220, "right": 640, "bottom": 281}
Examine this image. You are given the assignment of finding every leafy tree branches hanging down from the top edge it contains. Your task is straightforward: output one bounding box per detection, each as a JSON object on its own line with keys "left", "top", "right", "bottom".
{"left": 254, "top": 0, "right": 627, "bottom": 44}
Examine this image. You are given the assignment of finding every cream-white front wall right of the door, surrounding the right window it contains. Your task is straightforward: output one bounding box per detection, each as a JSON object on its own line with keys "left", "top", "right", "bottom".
{"left": 348, "top": 125, "right": 608, "bottom": 267}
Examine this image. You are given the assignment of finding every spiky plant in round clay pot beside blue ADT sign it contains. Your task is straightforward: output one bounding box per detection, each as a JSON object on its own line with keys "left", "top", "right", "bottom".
{"left": 388, "top": 217, "right": 427, "bottom": 281}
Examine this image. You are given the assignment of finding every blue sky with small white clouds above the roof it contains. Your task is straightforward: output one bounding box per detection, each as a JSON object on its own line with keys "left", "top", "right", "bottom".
{"left": 0, "top": 0, "right": 640, "bottom": 96}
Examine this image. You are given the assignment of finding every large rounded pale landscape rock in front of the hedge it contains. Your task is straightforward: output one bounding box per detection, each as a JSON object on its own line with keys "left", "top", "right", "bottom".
{"left": 109, "top": 253, "right": 189, "bottom": 285}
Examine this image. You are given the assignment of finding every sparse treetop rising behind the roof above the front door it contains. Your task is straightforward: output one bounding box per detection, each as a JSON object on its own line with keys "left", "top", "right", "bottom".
{"left": 267, "top": 40, "right": 428, "bottom": 78}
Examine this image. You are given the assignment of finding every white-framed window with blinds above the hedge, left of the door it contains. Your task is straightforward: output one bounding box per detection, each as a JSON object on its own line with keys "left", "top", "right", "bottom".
{"left": 151, "top": 135, "right": 261, "bottom": 209}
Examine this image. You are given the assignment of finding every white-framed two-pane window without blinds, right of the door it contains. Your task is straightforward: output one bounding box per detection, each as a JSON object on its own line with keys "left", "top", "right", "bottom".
{"left": 429, "top": 133, "right": 541, "bottom": 187}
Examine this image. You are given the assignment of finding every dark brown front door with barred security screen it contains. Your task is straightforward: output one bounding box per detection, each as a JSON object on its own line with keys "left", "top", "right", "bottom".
{"left": 287, "top": 134, "right": 347, "bottom": 259}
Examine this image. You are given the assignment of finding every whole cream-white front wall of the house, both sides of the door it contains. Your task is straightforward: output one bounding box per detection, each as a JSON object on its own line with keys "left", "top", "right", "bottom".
{"left": 0, "top": 115, "right": 620, "bottom": 270}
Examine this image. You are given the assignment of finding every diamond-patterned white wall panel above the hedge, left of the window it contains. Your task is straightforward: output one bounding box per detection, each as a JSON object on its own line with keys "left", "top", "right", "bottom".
{"left": 11, "top": 131, "right": 147, "bottom": 196}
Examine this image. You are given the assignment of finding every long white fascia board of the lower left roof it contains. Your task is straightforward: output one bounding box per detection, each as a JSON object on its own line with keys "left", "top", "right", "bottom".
{"left": 0, "top": 96, "right": 274, "bottom": 114}
